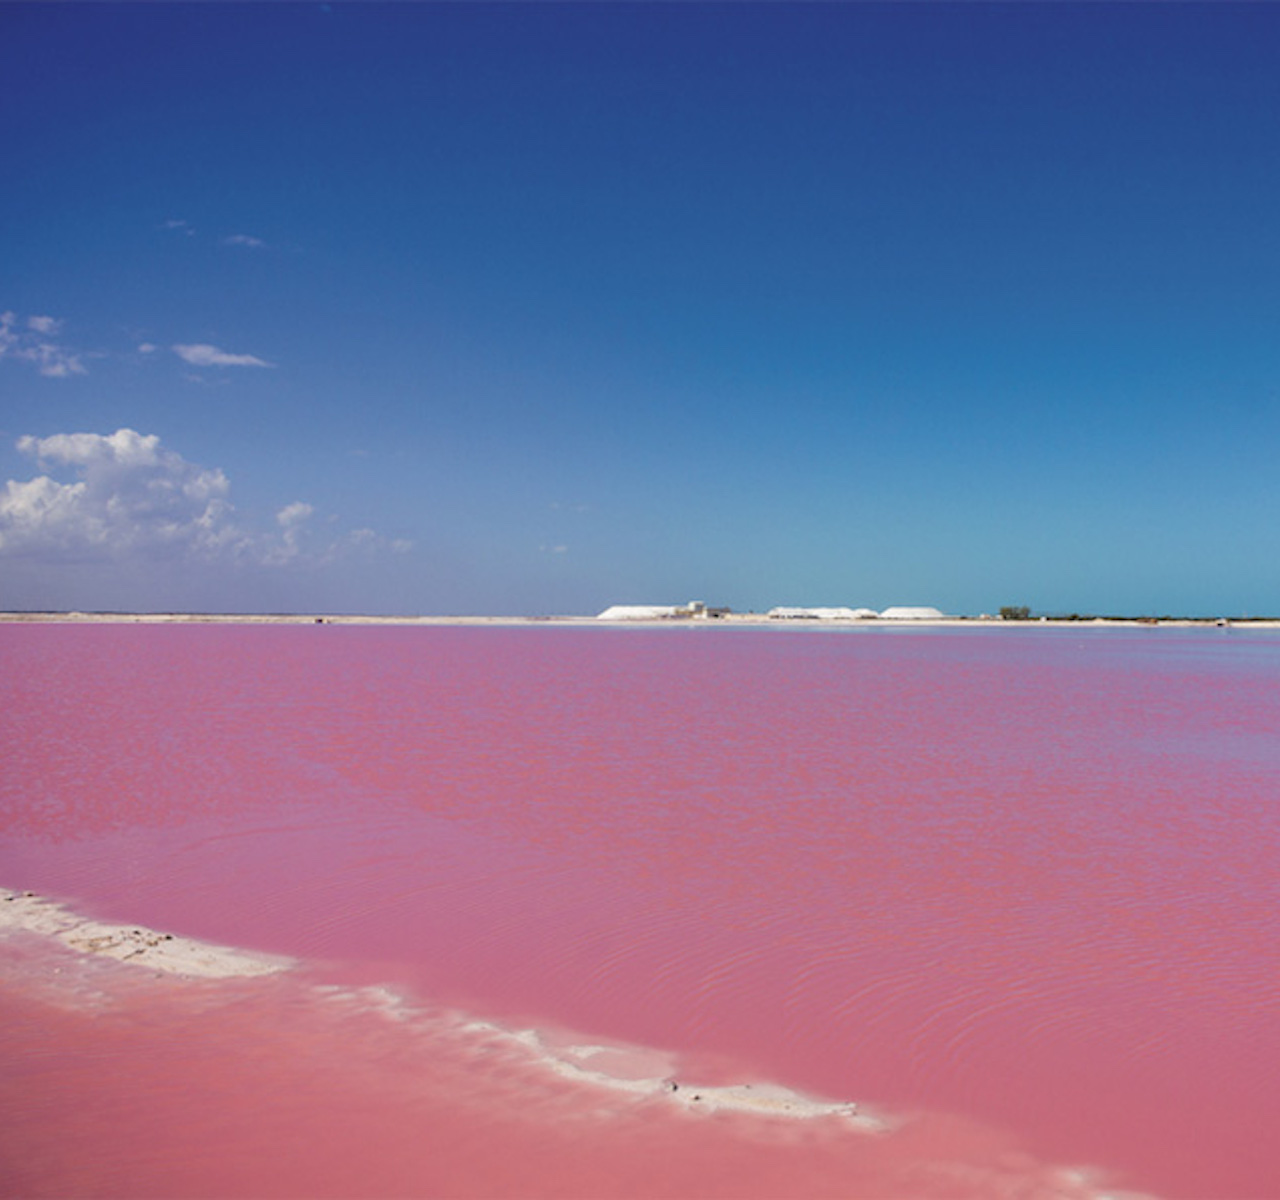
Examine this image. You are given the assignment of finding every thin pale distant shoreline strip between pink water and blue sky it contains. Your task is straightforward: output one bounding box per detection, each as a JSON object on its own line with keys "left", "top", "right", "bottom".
{"left": 0, "top": 612, "right": 1280, "bottom": 629}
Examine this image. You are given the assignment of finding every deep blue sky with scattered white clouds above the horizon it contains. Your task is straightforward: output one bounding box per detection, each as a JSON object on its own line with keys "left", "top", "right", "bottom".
{"left": 0, "top": 3, "right": 1280, "bottom": 614}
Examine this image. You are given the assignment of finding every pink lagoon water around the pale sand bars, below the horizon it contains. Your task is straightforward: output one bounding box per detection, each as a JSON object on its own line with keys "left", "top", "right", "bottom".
{"left": 0, "top": 626, "right": 1280, "bottom": 1197}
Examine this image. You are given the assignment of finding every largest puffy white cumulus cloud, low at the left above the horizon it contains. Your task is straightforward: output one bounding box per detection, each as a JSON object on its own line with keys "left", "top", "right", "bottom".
{"left": 0, "top": 429, "right": 398, "bottom": 567}
